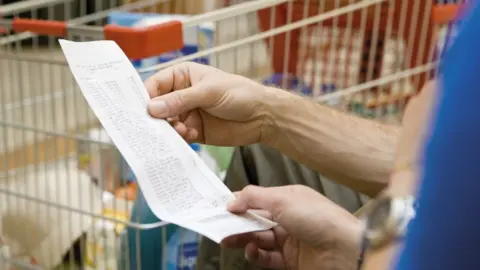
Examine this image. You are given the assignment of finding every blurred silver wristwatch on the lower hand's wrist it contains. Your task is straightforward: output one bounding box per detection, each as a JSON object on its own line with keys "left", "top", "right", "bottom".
{"left": 358, "top": 195, "right": 417, "bottom": 269}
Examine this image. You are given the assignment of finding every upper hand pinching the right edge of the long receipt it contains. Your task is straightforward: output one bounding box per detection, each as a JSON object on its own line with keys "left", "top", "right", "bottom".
{"left": 145, "top": 63, "right": 281, "bottom": 146}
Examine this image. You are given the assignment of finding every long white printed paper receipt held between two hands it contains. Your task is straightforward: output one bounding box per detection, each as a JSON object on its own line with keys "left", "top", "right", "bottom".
{"left": 60, "top": 40, "right": 276, "bottom": 243}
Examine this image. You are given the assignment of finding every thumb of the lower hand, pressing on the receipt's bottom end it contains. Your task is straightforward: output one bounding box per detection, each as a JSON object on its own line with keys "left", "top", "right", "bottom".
{"left": 228, "top": 186, "right": 287, "bottom": 219}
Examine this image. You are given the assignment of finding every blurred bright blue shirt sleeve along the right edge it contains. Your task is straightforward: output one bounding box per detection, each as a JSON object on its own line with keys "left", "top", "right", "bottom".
{"left": 395, "top": 1, "right": 480, "bottom": 270}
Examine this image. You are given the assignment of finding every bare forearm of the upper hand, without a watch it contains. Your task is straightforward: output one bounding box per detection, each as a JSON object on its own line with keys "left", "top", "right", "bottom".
{"left": 264, "top": 90, "right": 400, "bottom": 195}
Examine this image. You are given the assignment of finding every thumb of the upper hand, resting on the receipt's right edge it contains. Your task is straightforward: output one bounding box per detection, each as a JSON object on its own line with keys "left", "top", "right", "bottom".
{"left": 147, "top": 87, "right": 208, "bottom": 118}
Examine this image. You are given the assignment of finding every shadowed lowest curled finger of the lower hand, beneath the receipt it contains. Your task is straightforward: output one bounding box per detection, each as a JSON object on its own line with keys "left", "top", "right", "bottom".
{"left": 245, "top": 243, "right": 285, "bottom": 269}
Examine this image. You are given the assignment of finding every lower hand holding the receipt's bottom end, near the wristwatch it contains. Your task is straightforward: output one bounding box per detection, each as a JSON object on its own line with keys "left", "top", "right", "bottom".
{"left": 222, "top": 185, "right": 360, "bottom": 270}
